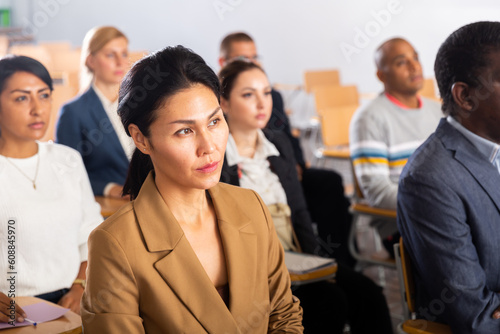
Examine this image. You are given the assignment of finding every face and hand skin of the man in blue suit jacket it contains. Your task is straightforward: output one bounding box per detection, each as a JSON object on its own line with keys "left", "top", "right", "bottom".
{"left": 448, "top": 51, "right": 500, "bottom": 319}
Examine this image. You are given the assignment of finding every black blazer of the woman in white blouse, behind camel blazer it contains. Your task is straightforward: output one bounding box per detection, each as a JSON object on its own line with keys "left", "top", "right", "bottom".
{"left": 221, "top": 129, "right": 318, "bottom": 254}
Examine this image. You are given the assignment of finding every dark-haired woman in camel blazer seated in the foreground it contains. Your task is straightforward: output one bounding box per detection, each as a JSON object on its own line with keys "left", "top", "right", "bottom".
{"left": 82, "top": 46, "right": 303, "bottom": 334}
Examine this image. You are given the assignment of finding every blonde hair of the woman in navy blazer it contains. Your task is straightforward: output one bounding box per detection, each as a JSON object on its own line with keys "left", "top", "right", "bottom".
{"left": 80, "top": 26, "right": 128, "bottom": 93}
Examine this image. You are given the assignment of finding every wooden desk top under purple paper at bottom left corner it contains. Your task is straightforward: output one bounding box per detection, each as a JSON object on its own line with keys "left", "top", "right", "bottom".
{"left": 0, "top": 297, "right": 82, "bottom": 334}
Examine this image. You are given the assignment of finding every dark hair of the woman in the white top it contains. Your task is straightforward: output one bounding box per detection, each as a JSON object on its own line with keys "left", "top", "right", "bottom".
{"left": 0, "top": 55, "right": 54, "bottom": 93}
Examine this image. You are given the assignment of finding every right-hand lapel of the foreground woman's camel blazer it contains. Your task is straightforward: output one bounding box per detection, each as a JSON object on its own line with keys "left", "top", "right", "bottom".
{"left": 209, "top": 186, "right": 258, "bottom": 319}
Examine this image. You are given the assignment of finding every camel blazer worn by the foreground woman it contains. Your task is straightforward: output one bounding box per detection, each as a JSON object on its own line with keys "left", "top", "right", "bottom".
{"left": 82, "top": 173, "right": 303, "bottom": 334}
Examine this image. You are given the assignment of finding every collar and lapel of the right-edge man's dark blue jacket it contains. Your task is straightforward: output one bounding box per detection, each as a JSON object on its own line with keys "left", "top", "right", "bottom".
{"left": 439, "top": 120, "right": 500, "bottom": 211}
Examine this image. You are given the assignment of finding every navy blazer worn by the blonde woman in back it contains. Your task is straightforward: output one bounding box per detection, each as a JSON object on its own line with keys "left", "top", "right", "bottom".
{"left": 56, "top": 88, "right": 129, "bottom": 196}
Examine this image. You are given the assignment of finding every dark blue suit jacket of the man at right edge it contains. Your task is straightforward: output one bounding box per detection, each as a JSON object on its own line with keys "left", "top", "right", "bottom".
{"left": 397, "top": 119, "right": 500, "bottom": 333}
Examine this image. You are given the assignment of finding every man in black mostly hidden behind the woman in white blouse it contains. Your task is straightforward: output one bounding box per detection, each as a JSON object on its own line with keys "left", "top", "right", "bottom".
{"left": 219, "top": 32, "right": 356, "bottom": 267}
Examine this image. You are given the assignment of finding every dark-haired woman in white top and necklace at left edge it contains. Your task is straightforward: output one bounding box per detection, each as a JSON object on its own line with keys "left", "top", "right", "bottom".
{"left": 0, "top": 56, "right": 102, "bottom": 322}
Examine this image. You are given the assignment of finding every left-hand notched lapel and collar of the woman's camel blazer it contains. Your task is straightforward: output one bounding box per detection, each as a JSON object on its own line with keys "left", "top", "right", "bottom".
{"left": 134, "top": 173, "right": 239, "bottom": 333}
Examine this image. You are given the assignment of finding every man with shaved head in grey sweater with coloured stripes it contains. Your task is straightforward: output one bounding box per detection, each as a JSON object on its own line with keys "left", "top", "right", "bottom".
{"left": 349, "top": 38, "right": 441, "bottom": 252}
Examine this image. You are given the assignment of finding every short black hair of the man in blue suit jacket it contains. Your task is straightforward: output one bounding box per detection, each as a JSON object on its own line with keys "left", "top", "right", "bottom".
{"left": 434, "top": 21, "right": 500, "bottom": 115}
